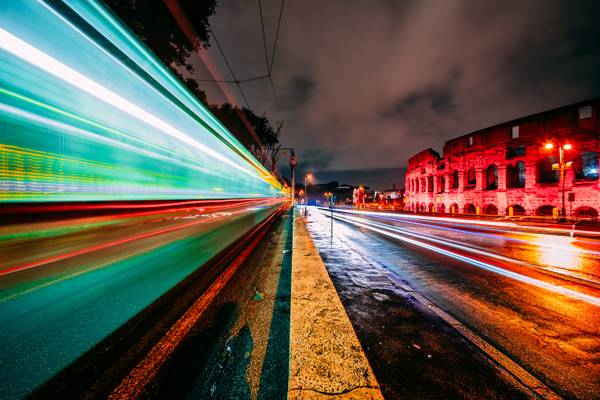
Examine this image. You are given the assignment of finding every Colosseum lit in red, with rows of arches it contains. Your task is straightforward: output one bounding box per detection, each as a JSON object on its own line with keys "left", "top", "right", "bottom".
{"left": 405, "top": 99, "right": 600, "bottom": 219}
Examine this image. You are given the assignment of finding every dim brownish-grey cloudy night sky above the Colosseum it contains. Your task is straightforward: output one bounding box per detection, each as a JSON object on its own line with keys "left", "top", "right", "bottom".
{"left": 191, "top": 0, "right": 600, "bottom": 189}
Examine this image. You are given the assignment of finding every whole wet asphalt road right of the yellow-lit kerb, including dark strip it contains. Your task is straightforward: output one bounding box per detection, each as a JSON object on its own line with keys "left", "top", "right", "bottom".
{"left": 308, "top": 208, "right": 600, "bottom": 399}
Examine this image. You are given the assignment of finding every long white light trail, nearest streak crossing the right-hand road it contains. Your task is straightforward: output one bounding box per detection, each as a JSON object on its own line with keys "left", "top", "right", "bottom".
{"left": 334, "top": 211, "right": 600, "bottom": 307}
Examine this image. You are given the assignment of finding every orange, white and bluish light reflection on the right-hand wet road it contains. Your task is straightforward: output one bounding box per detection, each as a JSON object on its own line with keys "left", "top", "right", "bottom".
{"left": 309, "top": 208, "right": 600, "bottom": 399}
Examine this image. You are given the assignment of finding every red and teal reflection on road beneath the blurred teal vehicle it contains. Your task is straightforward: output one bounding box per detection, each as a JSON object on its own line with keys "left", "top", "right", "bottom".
{"left": 0, "top": 200, "right": 281, "bottom": 399}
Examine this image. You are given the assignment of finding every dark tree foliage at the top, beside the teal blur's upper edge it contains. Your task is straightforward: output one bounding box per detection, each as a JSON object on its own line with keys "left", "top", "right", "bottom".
{"left": 104, "top": 0, "right": 217, "bottom": 104}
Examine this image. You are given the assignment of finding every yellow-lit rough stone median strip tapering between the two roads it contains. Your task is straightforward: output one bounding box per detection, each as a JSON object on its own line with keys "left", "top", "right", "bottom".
{"left": 288, "top": 213, "right": 383, "bottom": 399}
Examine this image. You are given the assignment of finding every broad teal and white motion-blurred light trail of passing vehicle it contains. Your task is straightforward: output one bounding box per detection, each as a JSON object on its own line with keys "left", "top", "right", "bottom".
{"left": 0, "top": 0, "right": 283, "bottom": 202}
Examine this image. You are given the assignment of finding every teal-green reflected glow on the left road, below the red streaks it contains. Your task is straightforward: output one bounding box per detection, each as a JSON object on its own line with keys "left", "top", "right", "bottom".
{"left": 0, "top": 207, "right": 274, "bottom": 399}
